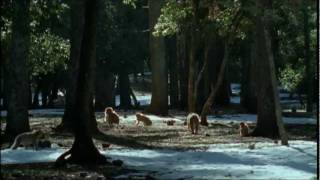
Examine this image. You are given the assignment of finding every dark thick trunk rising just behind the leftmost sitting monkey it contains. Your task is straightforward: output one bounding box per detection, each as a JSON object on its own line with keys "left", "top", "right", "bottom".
{"left": 95, "top": 70, "right": 115, "bottom": 110}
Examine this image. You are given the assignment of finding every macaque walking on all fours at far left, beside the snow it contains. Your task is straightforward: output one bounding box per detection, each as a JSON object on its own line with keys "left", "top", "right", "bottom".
{"left": 10, "top": 130, "right": 45, "bottom": 150}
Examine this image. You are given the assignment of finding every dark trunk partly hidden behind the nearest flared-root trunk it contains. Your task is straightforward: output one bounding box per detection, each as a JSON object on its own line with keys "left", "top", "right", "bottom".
{"left": 56, "top": 0, "right": 98, "bottom": 131}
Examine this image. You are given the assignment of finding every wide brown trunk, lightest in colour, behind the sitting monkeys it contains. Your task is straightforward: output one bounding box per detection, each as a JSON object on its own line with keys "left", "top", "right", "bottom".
{"left": 147, "top": 0, "right": 168, "bottom": 115}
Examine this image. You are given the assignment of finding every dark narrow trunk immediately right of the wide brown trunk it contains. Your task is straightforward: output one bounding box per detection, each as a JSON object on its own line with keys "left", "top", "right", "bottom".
{"left": 166, "top": 37, "right": 179, "bottom": 108}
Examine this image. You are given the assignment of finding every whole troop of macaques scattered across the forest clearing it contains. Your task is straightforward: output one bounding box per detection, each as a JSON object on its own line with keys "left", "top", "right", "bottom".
{"left": 10, "top": 107, "right": 249, "bottom": 150}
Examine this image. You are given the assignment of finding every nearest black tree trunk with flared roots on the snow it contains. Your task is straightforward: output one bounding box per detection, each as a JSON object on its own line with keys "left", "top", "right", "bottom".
{"left": 56, "top": 0, "right": 106, "bottom": 165}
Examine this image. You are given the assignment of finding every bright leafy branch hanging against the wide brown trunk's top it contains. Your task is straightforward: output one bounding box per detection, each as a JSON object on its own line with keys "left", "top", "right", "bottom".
{"left": 153, "top": 0, "right": 192, "bottom": 36}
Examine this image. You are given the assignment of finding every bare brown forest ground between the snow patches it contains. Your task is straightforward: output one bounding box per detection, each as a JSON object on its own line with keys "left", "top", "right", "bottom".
{"left": 1, "top": 108, "right": 317, "bottom": 179}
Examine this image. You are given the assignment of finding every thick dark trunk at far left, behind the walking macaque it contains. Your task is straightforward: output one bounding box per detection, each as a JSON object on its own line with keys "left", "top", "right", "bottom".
{"left": 5, "top": 0, "right": 30, "bottom": 136}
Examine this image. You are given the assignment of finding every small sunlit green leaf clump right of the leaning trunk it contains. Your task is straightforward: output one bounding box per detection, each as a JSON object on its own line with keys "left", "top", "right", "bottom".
{"left": 279, "top": 65, "right": 305, "bottom": 92}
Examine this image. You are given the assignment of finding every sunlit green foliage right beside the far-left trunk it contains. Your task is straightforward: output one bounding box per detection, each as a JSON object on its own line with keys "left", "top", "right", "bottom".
{"left": 28, "top": 31, "right": 70, "bottom": 76}
